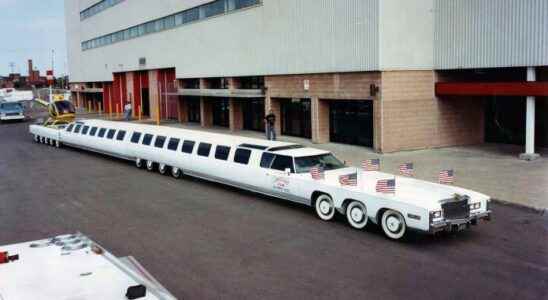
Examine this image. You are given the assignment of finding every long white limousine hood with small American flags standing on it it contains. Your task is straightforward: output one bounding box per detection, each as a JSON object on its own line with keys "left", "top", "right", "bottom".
{"left": 325, "top": 168, "right": 489, "bottom": 209}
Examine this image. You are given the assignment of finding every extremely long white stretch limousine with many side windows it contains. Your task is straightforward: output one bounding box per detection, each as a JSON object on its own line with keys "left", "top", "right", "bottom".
{"left": 30, "top": 120, "right": 491, "bottom": 239}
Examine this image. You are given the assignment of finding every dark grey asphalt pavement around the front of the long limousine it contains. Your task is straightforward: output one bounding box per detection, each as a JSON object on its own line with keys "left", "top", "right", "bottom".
{"left": 0, "top": 123, "right": 548, "bottom": 299}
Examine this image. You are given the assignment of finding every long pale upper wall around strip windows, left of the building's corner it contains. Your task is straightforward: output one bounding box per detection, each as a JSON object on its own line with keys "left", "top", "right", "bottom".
{"left": 65, "top": 0, "right": 379, "bottom": 82}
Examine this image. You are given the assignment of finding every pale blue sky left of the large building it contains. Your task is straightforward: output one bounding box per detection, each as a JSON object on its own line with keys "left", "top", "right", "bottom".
{"left": 0, "top": 0, "right": 67, "bottom": 76}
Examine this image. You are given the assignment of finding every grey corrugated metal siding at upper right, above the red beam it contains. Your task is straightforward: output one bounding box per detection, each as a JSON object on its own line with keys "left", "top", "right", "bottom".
{"left": 434, "top": 0, "right": 548, "bottom": 69}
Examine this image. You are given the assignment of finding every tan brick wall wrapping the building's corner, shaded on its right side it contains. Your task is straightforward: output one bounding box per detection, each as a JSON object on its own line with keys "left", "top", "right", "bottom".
{"left": 378, "top": 71, "right": 484, "bottom": 152}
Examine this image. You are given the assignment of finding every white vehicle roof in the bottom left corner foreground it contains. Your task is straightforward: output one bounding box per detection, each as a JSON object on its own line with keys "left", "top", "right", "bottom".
{"left": 0, "top": 234, "right": 175, "bottom": 300}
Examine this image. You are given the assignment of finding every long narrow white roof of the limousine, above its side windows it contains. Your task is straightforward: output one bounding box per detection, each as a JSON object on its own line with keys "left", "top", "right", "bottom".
{"left": 75, "top": 119, "right": 316, "bottom": 155}
